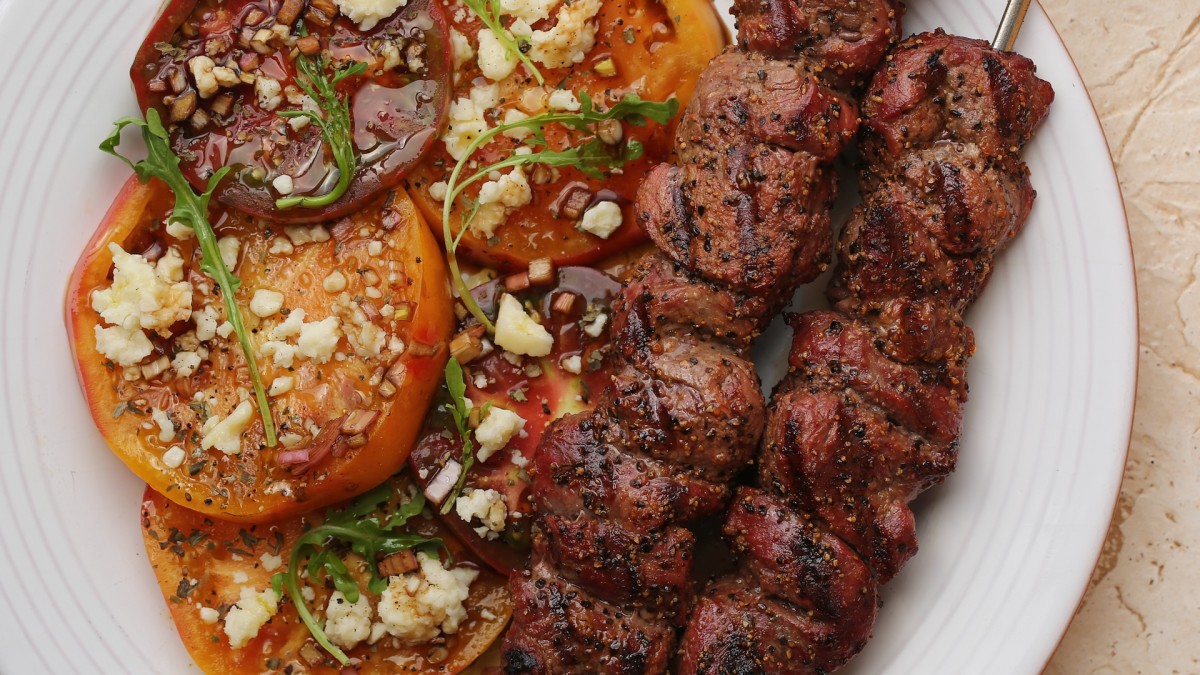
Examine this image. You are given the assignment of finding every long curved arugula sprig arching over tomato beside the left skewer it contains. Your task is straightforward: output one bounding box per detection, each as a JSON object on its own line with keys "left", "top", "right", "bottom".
{"left": 442, "top": 91, "right": 679, "bottom": 329}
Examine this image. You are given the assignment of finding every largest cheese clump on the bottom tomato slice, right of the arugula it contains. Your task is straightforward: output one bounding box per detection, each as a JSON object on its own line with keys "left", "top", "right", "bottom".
{"left": 378, "top": 552, "right": 479, "bottom": 644}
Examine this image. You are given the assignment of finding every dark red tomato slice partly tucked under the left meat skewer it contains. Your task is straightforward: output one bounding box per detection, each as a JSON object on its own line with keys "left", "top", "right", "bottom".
{"left": 410, "top": 267, "right": 620, "bottom": 574}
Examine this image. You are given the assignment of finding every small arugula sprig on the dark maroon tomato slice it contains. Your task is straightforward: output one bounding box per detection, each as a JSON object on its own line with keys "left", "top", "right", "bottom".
{"left": 275, "top": 47, "right": 367, "bottom": 209}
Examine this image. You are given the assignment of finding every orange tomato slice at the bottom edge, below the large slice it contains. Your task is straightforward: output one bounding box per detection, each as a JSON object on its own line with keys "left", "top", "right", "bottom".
{"left": 142, "top": 477, "right": 512, "bottom": 675}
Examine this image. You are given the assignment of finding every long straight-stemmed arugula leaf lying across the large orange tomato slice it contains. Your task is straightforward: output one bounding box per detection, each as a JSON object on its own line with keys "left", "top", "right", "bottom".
{"left": 100, "top": 108, "right": 276, "bottom": 448}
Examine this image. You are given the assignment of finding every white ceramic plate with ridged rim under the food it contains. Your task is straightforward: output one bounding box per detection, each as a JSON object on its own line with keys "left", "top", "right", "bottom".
{"left": 0, "top": 0, "right": 1136, "bottom": 675}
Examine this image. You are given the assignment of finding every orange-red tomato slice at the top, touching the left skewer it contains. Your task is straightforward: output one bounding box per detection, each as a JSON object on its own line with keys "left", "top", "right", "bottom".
{"left": 407, "top": 0, "right": 727, "bottom": 271}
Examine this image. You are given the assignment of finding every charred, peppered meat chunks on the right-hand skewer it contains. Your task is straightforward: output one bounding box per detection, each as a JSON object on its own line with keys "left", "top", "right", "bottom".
{"left": 677, "top": 31, "right": 1054, "bottom": 675}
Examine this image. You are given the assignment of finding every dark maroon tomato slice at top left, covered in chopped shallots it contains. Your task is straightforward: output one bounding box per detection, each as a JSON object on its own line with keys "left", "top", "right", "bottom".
{"left": 130, "top": 0, "right": 451, "bottom": 222}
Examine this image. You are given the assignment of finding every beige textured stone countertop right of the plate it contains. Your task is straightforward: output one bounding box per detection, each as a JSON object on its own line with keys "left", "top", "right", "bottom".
{"left": 1041, "top": 0, "right": 1200, "bottom": 675}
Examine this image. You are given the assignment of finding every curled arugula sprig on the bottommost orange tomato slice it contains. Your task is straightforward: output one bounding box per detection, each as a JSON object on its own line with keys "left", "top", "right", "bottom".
{"left": 271, "top": 483, "right": 449, "bottom": 665}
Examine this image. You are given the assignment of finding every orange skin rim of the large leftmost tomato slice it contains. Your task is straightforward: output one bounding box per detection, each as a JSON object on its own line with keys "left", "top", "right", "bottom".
{"left": 66, "top": 178, "right": 455, "bottom": 521}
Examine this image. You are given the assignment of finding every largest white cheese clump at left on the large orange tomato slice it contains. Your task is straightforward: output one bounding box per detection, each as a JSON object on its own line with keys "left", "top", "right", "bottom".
{"left": 91, "top": 243, "right": 192, "bottom": 336}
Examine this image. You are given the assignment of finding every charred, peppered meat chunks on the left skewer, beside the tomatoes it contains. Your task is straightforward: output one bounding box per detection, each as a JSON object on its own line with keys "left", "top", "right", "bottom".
{"left": 502, "top": 0, "right": 899, "bottom": 675}
